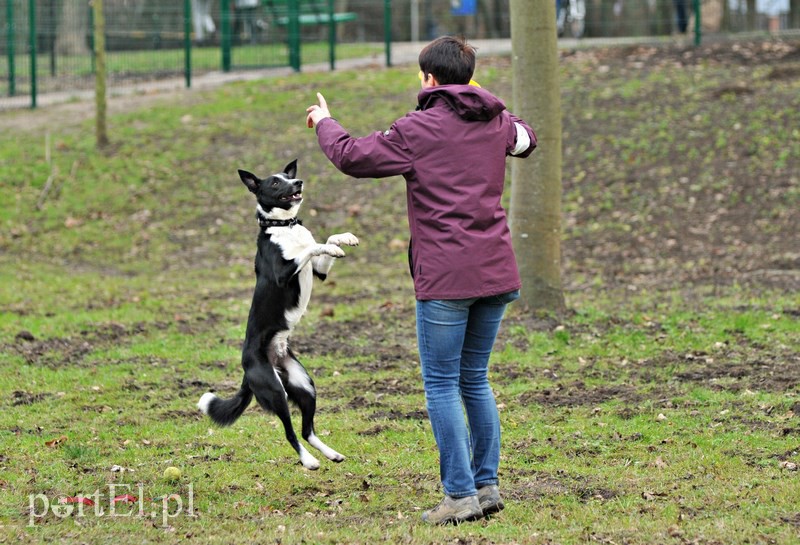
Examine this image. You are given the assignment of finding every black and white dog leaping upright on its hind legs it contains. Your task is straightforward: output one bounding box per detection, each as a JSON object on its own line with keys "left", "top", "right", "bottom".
{"left": 197, "top": 160, "right": 358, "bottom": 469}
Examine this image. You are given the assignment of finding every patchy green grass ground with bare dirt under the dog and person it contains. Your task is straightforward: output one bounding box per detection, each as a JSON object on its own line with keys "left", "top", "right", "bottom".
{"left": 0, "top": 39, "right": 800, "bottom": 545}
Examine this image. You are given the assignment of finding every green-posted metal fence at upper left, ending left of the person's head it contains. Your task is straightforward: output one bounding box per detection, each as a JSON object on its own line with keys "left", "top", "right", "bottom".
{"left": 0, "top": 0, "right": 390, "bottom": 108}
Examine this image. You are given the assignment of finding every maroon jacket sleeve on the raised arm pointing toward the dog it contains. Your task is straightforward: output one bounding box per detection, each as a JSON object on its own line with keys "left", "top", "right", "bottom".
{"left": 317, "top": 118, "right": 413, "bottom": 178}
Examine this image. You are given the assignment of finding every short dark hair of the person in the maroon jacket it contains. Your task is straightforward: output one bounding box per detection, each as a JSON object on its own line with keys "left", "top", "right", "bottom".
{"left": 419, "top": 36, "right": 475, "bottom": 85}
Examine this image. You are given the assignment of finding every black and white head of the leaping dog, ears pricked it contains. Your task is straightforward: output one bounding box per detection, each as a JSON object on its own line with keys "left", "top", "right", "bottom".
{"left": 239, "top": 159, "right": 303, "bottom": 220}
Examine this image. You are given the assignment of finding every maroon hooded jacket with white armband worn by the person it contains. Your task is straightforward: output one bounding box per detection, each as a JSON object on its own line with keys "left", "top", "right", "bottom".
{"left": 316, "top": 85, "right": 536, "bottom": 301}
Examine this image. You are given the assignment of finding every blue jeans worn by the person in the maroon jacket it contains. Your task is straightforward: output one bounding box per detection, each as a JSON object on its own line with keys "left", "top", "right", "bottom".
{"left": 417, "top": 291, "right": 519, "bottom": 498}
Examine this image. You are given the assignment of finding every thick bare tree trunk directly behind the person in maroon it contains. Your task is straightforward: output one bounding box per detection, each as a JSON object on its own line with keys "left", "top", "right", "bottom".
{"left": 510, "top": 0, "right": 564, "bottom": 312}
